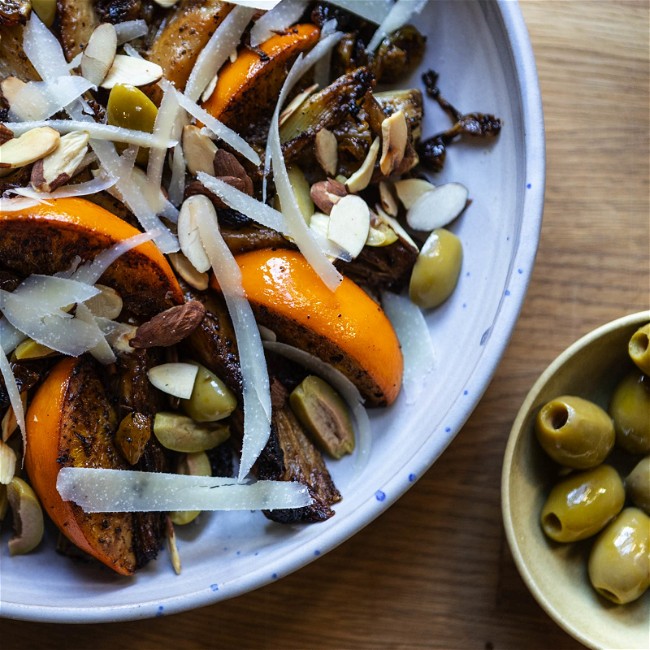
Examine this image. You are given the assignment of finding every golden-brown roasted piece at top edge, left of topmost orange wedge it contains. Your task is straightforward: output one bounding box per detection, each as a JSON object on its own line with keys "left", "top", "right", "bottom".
{"left": 145, "top": 0, "right": 233, "bottom": 103}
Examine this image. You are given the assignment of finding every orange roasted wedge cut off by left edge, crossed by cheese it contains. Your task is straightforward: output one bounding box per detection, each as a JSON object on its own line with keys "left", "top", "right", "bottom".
{"left": 0, "top": 199, "right": 183, "bottom": 315}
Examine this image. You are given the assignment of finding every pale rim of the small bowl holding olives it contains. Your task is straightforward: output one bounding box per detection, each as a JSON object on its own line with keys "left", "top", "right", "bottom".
{"left": 501, "top": 310, "right": 650, "bottom": 650}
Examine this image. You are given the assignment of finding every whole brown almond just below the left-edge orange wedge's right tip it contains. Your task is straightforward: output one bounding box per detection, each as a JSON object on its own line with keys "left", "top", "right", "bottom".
{"left": 130, "top": 300, "right": 205, "bottom": 348}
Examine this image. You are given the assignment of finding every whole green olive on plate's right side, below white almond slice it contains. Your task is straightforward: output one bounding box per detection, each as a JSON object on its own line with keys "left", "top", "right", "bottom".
{"left": 409, "top": 228, "right": 463, "bottom": 309}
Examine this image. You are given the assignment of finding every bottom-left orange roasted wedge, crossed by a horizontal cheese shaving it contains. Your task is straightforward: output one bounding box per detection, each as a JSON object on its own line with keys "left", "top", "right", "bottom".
{"left": 25, "top": 357, "right": 159, "bottom": 575}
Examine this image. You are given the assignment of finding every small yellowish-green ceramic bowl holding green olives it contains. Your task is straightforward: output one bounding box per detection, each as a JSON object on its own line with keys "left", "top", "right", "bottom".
{"left": 501, "top": 311, "right": 650, "bottom": 650}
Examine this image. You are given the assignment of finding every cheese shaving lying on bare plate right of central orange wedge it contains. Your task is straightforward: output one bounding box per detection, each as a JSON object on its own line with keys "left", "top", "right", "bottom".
{"left": 381, "top": 291, "right": 436, "bottom": 405}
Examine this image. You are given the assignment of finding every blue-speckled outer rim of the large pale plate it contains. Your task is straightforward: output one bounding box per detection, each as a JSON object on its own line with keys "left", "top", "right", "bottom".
{"left": 0, "top": 0, "right": 545, "bottom": 623}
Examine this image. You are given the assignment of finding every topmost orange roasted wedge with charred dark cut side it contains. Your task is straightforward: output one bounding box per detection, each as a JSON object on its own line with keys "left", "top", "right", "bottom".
{"left": 204, "top": 24, "right": 320, "bottom": 134}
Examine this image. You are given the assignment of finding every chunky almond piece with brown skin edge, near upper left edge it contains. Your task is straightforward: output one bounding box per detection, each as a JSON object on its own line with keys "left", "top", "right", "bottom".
{"left": 31, "top": 131, "right": 90, "bottom": 192}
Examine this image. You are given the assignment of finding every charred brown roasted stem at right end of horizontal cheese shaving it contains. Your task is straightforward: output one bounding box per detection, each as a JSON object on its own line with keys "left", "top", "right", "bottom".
{"left": 255, "top": 378, "right": 341, "bottom": 523}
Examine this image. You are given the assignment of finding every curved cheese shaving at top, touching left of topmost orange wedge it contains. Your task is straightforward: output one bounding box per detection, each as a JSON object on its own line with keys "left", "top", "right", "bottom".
{"left": 185, "top": 3, "right": 256, "bottom": 102}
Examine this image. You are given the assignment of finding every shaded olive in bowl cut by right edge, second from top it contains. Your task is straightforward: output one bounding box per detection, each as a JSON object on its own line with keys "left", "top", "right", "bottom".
{"left": 609, "top": 370, "right": 650, "bottom": 454}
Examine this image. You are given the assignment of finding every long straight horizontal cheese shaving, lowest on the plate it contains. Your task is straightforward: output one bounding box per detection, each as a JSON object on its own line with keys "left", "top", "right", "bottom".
{"left": 56, "top": 467, "right": 312, "bottom": 512}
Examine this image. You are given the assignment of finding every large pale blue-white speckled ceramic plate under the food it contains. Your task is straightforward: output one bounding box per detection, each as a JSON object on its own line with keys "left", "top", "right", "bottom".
{"left": 0, "top": 0, "right": 544, "bottom": 623}
